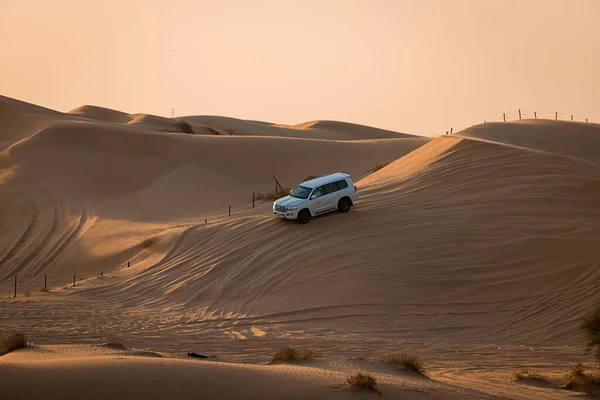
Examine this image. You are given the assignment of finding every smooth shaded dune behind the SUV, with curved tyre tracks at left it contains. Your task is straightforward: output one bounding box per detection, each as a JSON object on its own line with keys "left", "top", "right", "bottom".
{"left": 0, "top": 99, "right": 428, "bottom": 290}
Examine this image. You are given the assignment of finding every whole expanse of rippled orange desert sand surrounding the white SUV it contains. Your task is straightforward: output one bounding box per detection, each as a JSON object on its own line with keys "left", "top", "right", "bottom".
{"left": 0, "top": 95, "right": 600, "bottom": 399}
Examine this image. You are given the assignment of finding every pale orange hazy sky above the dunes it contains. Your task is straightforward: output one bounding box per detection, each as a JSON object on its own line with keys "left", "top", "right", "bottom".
{"left": 0, "top": 0, "right": 600, "bottom": 135}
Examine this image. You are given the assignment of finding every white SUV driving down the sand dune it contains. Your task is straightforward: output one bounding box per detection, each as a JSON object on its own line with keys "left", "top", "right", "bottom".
{"left": 273, "top": 172, "right": 358, "bottom": 224}
